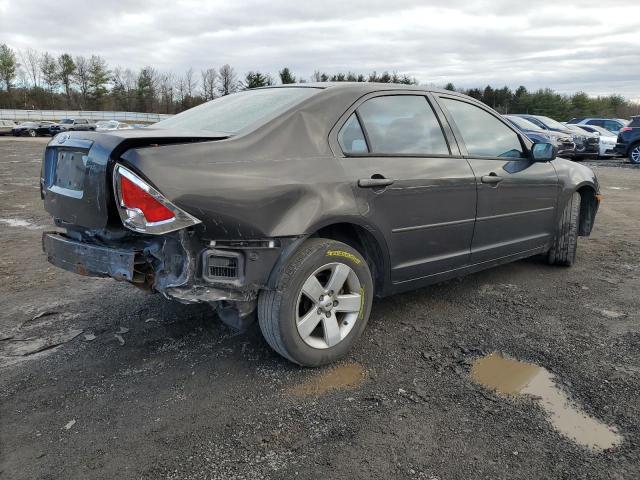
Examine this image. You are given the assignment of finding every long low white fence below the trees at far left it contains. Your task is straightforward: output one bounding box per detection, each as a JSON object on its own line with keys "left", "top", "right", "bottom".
{"left": 0, "top": 109, "right": 172, "bottom": 123}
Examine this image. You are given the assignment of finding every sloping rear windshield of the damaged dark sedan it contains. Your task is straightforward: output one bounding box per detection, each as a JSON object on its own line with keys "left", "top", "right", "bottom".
{"left": 153, "top": 87, "right": 319, "bottom": 133}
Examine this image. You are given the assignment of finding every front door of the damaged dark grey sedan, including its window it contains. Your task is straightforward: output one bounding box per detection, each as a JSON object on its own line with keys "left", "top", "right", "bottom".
{"left": 438, "top": 94, "right": 559, "bottom": 264}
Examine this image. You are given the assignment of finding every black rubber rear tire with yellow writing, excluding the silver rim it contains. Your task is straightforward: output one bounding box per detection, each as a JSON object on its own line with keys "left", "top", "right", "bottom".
{"left": 258, "top": 238, "right": 373, "bottom": 367}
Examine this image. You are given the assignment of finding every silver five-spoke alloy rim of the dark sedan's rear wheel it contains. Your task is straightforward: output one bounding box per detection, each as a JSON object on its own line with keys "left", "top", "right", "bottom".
{"left": 296, "top": 263, "right": 363, "bottom": 349}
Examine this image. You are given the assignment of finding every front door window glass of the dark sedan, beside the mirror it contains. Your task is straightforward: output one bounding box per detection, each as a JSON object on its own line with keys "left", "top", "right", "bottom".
{"left": 441, "top": 98, "right": 524, "bottom": 158}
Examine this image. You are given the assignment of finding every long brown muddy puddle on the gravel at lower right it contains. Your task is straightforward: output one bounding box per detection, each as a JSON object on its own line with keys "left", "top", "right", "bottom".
{"left": 471, "top": 352, "right": 623, "bottom": 450}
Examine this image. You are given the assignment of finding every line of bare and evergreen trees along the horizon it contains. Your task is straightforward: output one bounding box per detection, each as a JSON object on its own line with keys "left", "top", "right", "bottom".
{"left": 0, "top": 44, "right": 640, "bottom": 120}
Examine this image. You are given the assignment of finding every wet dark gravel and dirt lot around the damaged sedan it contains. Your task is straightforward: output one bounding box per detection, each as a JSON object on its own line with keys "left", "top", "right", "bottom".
{"left": 0, "top": 139, "right": 640, "bottom": 480}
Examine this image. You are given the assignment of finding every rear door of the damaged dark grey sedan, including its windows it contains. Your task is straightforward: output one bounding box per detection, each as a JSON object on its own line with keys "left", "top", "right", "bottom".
{"left": 336, "top": 92, "right": 476, "bottom": 284}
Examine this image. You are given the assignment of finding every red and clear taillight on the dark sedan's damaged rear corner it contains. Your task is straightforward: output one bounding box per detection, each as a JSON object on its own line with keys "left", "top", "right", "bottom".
{"left": 113, "top": 165, "right": 200, "bottom": 235}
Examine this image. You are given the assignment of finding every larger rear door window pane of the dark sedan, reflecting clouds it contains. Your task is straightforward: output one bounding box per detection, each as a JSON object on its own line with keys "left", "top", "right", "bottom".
{"left": 358, "top": 95, "right": 449, "bottom": 155}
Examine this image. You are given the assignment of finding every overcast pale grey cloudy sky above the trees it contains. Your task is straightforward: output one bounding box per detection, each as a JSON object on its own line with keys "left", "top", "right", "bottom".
{"left": 0, "top": 0, "right": 640, "bottom": 99}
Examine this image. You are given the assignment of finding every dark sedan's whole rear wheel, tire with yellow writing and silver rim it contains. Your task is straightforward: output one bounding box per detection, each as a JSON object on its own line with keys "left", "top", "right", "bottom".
{"left": 258, "top": 238, "right": 373, "bottom": 367}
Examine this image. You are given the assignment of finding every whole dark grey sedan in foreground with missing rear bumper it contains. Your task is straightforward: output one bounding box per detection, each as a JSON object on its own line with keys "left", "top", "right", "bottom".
{"left": 40, "top": 83, "right": 601, "bottom": 366}
